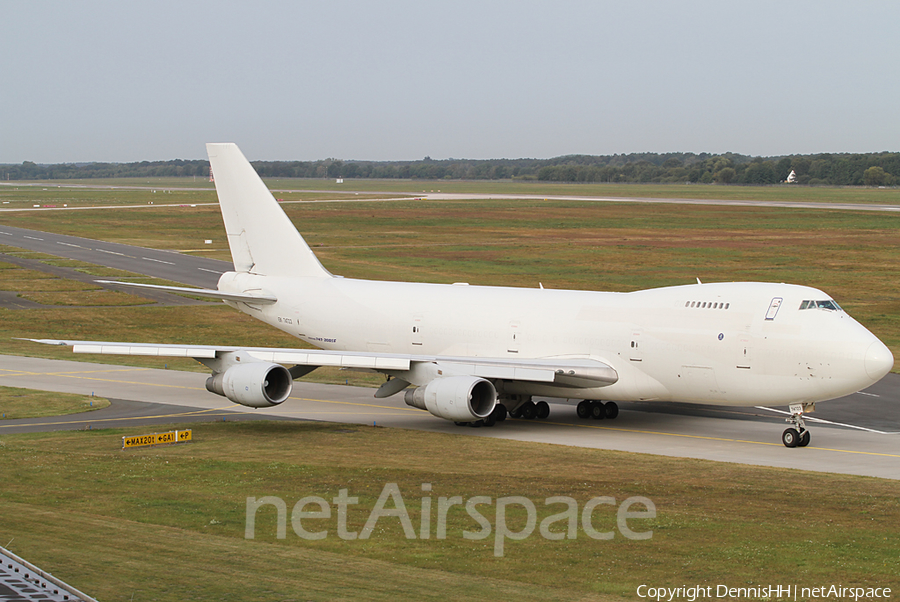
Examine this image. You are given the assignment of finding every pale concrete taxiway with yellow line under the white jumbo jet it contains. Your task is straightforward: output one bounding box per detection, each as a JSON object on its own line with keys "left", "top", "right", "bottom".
{"left": 0, "top": 356, "right": 900, "bottom": 479}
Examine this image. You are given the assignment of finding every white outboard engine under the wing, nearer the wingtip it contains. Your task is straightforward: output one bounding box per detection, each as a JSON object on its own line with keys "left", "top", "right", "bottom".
{"left": 206, "top": 362, "right": 293, "bottom": 408}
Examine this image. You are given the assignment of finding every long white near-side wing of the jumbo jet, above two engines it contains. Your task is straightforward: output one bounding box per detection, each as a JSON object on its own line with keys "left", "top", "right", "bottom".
{"left": 28, "top": 339, "right": 619, "bottom": 388}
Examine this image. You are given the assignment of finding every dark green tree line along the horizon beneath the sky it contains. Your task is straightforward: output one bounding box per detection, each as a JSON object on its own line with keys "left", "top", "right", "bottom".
{"left": 0, "top": 152, "right": 900, "bottom": 186}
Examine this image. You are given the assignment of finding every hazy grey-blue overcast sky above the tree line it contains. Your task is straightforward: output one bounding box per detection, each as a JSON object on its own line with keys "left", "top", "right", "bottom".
{"left": 0, "top": 0, "right": 900, "bottom": 163}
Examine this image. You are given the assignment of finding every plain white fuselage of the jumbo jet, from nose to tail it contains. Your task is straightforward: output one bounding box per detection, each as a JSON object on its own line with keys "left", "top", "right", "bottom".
{"left": 220, "top": 274, "right": 892, "bottom": 406}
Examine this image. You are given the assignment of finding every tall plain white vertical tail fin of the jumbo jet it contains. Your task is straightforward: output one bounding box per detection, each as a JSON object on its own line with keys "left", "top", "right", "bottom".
{"left": 206, "top": 143, "right": 331, "bottom": 278}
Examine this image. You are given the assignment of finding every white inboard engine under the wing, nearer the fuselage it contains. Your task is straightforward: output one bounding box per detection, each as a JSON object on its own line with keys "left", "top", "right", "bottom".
{"left": 404, "top": 376, "right": 497, "bottom": 422}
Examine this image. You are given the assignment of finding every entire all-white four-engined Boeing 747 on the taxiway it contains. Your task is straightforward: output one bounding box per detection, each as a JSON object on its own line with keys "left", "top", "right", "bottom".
{"left": 29, "top": 144, "right": 894, "bottom": 447}
